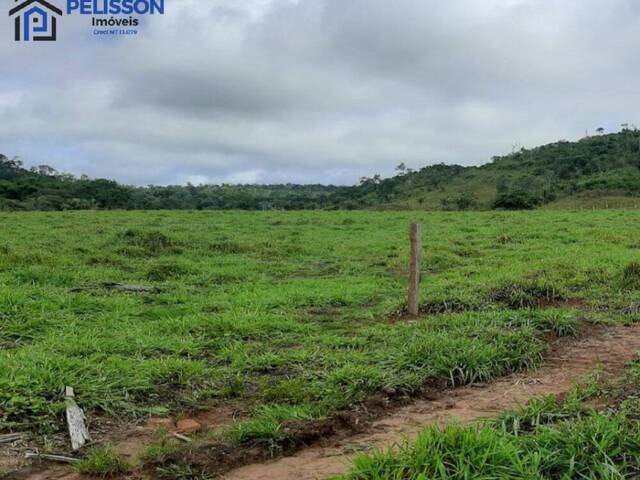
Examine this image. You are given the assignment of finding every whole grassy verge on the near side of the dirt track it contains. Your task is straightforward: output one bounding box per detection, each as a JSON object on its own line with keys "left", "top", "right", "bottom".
{"left": 339, "top": 362, "right": 640, "bottom": 480}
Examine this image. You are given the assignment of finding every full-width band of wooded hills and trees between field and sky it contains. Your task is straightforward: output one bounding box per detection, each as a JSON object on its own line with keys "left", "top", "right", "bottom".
{"left": 0, "top": 129, "right": 640, "bottom": 210}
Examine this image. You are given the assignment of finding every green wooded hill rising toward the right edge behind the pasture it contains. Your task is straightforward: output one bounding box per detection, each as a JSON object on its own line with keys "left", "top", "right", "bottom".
{"left": 337, "top": 129, "right": 640, "bottom": 210}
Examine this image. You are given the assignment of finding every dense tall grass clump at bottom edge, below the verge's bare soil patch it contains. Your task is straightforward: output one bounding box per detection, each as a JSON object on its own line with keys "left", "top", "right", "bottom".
{"left": 341, "top": 415, "right": 640, "bottom": 480}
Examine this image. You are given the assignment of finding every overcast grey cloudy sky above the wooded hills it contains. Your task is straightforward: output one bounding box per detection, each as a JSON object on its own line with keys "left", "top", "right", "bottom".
{"left": 0, "top": 0, "right": 640, "bottom": 185}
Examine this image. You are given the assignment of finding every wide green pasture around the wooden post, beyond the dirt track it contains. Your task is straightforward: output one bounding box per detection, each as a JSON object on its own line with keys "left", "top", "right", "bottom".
{"left": 0, "top": 210, "right": 640, "bottom": 472}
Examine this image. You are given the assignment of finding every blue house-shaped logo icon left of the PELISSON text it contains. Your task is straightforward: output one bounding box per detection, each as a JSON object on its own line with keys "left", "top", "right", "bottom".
{"left": 9, "top": 0, "right": 62, "bottom": 42}
